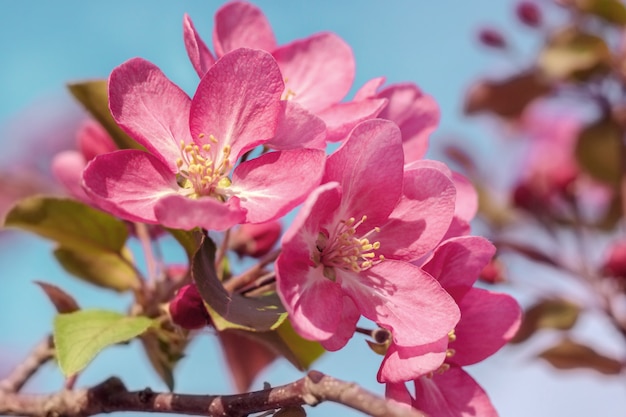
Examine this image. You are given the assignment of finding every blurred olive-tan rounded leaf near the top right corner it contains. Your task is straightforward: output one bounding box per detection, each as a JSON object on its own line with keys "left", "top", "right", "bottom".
{"left": 538, "top": 28, "right": 611, "bottom": 81}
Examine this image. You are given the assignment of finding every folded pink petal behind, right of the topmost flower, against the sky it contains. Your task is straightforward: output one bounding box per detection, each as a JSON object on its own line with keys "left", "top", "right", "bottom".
{"left": 376, "top": 83, "right": 439, "bottom": 163}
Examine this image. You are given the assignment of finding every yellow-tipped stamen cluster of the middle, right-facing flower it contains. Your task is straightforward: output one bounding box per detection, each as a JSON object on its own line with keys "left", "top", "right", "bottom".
{"left": 313, "top": 216, "right": 385, "bottom": 281}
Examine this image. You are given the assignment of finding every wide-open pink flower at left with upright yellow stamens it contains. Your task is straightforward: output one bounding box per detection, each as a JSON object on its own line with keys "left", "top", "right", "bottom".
{"left": 83, "top": 49, "right": 325, "bottom": 230}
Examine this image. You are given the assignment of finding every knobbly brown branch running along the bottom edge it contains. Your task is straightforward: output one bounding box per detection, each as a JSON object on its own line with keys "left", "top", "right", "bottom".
{"left": 0, "top": 371, "right": 424, "bottom": 417}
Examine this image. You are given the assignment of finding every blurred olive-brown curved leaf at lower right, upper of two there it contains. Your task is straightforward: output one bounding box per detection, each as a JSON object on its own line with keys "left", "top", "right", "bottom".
{"left": 511, "top": 299, "right": 580, "bottom": 343}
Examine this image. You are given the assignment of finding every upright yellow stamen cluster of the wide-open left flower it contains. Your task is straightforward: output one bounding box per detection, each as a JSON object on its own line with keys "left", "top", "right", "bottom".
{"left": 176, "top": 134, "right": 232, "bottom": 201}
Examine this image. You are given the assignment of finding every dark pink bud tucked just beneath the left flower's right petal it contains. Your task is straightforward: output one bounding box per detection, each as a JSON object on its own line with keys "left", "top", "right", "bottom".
{"left": 230, "top": 221, "right": 282, "bottom": 258}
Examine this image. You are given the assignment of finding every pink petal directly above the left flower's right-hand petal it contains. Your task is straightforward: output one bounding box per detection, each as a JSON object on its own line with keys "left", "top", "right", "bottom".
{"left": 265, "top": 100, "right": 326, "bottom": 150}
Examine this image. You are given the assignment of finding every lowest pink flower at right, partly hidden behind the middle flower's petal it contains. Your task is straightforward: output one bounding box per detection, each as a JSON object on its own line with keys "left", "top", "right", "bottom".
{"left": 379, "top": 236, "right": 521, "bottom": 417}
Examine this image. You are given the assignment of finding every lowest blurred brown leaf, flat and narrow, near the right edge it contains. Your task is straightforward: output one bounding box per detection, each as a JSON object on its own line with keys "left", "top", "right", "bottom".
{"left": 539, "top": 339, "right": 623, "bottom": 375}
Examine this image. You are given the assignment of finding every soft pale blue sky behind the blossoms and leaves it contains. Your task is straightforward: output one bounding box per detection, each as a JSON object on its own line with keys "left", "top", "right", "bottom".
{"left": 0, "top": 0, "right": 626, "bottom": 417}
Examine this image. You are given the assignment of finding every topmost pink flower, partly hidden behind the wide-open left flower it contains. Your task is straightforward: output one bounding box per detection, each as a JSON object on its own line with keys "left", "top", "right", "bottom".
{"left": 183, "top": 1, "right": 385, "bottom": 141}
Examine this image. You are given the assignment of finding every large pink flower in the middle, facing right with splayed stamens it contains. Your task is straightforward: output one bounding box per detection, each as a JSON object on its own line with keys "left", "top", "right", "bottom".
{"left": 276, "top": 119, "right": 458, "bottom": 350}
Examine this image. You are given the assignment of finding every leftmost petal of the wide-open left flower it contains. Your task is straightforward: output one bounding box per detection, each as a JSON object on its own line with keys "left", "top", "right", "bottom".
{"left": 83, "top": 150, "right": 179, "bottom": 224}
